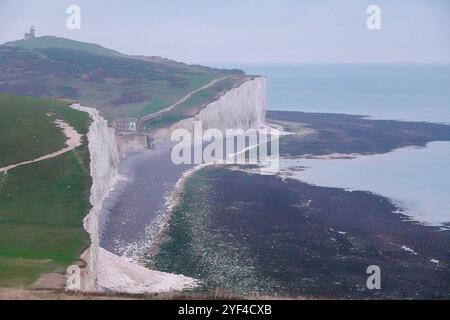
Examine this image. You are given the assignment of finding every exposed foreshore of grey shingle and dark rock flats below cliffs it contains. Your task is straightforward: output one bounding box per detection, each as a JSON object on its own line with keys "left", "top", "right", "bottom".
{"left": 96, "top": 112, "right": 450, "bottom": 298}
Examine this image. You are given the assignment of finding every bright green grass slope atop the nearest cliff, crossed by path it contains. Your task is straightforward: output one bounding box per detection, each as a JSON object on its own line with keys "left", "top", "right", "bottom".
{"left": 0, "top": 95, "right": 91, "bottom": 287}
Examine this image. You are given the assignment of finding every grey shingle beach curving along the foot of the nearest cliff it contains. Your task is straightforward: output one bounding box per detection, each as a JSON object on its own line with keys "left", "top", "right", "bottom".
{"left": 100, "top": 144, "right": 194, "bottom": 259}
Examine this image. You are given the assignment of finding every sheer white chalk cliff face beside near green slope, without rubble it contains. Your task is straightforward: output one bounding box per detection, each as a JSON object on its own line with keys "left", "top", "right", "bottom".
{"left": 68, "top": 104, "right": 120, "bottom": 291}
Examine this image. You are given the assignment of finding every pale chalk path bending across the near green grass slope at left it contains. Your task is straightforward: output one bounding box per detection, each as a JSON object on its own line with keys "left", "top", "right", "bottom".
{"left": 0, "top": 119, "right": 81, "bottom": 173}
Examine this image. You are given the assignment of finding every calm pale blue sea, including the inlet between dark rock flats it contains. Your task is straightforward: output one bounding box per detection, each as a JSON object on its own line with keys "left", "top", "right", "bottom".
{"left": 214, "top": 65, "right": 450, "bottom": 225}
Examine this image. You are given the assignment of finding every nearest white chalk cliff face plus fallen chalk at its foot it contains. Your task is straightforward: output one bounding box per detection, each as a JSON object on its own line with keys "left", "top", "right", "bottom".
{"left": 66, "top": 104, "right": 196, "bottom": 293}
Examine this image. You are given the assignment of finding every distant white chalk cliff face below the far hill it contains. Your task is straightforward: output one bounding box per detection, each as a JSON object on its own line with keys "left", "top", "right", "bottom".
{"left": 151, "top": 77, "right": 267, "bottom": 143}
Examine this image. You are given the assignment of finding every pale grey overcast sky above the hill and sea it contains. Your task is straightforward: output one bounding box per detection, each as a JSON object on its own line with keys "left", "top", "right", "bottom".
{"left": 0, "top": 0, "right": 450, "bottom": 64}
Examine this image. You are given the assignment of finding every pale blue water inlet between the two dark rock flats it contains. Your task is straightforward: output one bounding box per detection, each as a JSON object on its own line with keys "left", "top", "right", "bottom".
{"left": 280, "top": 142, "right": 450, "bottom": 226}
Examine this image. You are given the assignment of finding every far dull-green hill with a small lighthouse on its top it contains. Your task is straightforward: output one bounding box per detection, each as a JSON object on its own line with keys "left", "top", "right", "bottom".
{"left": 0, "top": 36, "right": 244, "bottom": 119}
